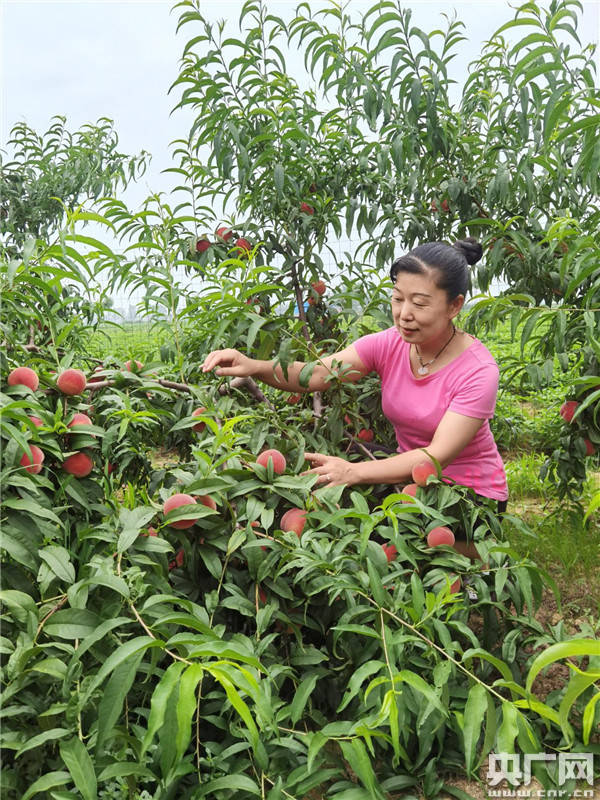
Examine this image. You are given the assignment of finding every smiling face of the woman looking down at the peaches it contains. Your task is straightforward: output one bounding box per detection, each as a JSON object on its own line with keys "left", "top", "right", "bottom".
{"left": 392, "top": 271, "right": 464, "bottom": 345}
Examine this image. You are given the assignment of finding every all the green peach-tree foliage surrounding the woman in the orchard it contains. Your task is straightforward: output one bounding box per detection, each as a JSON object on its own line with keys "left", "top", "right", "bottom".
{"left": 0, "top": 0, "right": 600, "bottom": 800}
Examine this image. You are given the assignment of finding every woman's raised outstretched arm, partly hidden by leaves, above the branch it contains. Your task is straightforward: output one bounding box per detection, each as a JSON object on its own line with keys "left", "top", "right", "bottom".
{"left": 202, "top": 345, "right": 368, "bottom": 392}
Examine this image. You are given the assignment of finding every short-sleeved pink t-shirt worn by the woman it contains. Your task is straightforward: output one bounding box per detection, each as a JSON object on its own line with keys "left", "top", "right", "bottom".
{"left": 354, "top": 327, "right": 508, "bottom": 500}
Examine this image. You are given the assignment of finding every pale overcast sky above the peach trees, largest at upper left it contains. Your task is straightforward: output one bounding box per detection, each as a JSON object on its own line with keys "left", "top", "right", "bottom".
{"left": 0, "top": 0, "right": 600, "bottom": 209}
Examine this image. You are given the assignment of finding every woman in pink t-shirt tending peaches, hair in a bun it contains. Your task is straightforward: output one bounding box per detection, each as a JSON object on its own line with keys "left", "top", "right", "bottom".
{"left": 203, "top": 238, "right": 508, "bottom": 544}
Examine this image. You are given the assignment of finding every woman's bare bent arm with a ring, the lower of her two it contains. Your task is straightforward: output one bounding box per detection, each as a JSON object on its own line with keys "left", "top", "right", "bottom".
{"left": 304, "top": 411, "right": 485, "bottom": 486}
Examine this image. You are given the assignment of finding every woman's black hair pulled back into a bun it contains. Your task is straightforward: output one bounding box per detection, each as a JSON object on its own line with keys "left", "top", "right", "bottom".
{"left": 390, "top": 236, "right": 483, "bottom": 301}
